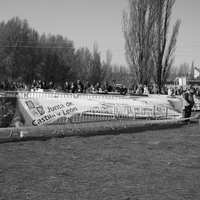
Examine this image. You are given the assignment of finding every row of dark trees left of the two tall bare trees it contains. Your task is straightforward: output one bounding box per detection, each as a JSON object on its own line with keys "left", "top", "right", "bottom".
{"left": 0, "top": 17, "right": 128, "bottom": 88}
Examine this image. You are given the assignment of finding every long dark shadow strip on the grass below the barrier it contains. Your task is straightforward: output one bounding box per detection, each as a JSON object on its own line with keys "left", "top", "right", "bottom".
{"left": 0, "top": 122, "right": 198, "bottom": 144}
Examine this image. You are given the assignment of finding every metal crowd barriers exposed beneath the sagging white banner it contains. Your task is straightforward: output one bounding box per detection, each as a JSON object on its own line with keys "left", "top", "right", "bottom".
{"left": 51, "top": 105, "right": 181, "bottom": 124}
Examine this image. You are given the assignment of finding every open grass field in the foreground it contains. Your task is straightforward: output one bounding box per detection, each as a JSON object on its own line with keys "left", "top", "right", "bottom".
{"left": 0, "top": 113, "right": 200, "bottom": 200}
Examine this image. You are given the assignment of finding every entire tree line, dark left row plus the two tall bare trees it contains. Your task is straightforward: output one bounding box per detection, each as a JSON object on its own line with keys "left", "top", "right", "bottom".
{"left": 0, "top": 0, "right": 181, "bottom": 91}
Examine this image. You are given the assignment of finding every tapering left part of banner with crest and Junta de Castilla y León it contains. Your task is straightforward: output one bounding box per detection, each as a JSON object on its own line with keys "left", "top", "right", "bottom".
{"left": 19, "top": 98, "right": 99, "bottom": 126}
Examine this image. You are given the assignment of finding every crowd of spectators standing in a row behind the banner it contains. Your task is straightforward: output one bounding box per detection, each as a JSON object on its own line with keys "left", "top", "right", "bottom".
{"left": 0, "top": 80, "right": 200, "bottom": 98}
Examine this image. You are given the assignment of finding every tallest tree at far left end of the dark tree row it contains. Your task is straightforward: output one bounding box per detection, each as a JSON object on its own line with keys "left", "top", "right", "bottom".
{"left": 0, "top": 17, "right": 30, "bottom": 81}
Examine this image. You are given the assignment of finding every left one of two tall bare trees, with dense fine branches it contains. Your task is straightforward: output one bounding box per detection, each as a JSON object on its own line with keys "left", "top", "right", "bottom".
{"left": 123, "top": 0, "right": 156, "bottom": 84}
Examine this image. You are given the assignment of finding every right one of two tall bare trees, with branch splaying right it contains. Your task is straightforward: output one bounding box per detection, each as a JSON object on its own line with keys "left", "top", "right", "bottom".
{"left": 153, "top": 0, "right": 181, "bottom": 91}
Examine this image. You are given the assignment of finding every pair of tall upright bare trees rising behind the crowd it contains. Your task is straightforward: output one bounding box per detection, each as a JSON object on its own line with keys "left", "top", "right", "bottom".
{"left": 123, "top": 0, "right": 180, "bottom": 91}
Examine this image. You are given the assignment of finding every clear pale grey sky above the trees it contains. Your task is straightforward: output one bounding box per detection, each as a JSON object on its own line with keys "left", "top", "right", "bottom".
{"left": 0, "top": 0, "right": 200, "bottom": 68}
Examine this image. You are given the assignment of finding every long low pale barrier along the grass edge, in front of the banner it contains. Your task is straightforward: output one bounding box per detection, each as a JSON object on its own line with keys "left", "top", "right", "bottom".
{"left": 0, "top": 111, "right": 200, "bottom": 138}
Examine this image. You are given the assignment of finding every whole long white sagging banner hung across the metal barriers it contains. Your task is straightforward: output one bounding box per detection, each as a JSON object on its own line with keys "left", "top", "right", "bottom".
{"left": 18, "top": 95, "right": 182, "bottom": 126}
